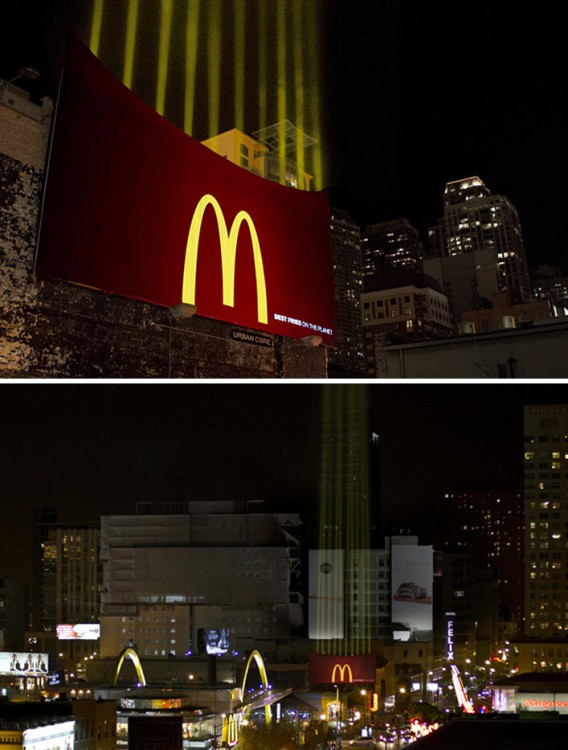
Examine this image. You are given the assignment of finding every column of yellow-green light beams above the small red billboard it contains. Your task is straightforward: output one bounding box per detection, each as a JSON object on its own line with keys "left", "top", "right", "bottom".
{"left": 310, "top": 385, "right": 376, "bottom": 656}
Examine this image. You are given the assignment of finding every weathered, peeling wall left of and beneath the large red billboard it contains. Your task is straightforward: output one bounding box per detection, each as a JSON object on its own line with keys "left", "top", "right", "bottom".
{"left": 0, "top": 104, "right": 326, "bottom": 379}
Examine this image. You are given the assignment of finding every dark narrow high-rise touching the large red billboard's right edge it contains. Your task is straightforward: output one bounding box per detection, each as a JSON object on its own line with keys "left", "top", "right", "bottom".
{"left": 328, "top": 208, "right": 365, "bottom": 377}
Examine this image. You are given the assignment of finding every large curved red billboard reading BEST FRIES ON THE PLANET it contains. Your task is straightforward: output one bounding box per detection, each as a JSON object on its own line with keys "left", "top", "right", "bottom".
{"left": 36, "top": 40, "right": 335, "bottom": 345}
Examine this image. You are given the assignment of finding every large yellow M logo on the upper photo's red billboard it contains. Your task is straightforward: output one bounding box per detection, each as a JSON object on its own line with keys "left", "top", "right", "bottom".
{"left": 182, "top": 193, "right": 268, "bottom": 323}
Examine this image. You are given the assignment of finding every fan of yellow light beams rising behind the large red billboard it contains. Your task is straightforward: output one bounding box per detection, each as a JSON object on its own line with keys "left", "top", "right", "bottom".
{"left": 87, "top": 0, "right": 326, "bottom": 189}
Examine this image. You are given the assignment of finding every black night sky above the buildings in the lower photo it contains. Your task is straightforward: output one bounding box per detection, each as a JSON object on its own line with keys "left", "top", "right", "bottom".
{"left": 0, "top": 383, "right": 568, "bottom": 592}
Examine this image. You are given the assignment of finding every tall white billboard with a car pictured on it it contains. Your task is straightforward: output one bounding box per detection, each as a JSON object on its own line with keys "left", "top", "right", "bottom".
{"left": 391, "top": 544, "right": 434, "bottom": 641}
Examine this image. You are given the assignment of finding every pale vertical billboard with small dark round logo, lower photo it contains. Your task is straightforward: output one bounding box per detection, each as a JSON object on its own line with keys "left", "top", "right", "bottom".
{"left": 308, "top": 549, "right": 344, "bottom": 640}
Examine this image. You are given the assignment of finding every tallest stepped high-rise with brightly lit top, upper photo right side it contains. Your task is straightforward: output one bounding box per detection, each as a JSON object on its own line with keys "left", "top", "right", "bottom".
{"left": 424, "top": 177, "right": 531, "bottom": 314}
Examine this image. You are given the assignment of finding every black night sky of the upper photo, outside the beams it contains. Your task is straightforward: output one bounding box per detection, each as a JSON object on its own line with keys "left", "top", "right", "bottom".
{"left": 0, "top": 0, "right": 568, "bottom": 273}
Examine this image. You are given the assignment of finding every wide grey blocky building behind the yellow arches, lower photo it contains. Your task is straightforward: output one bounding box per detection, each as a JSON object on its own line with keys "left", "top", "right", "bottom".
{"left": 101, "top": 502, "right": 301, "bottom": 659}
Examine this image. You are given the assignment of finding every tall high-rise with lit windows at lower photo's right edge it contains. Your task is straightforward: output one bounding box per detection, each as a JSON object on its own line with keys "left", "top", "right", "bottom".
{"left": 524, "top": 404, "right": 568, "bottom": 637}
